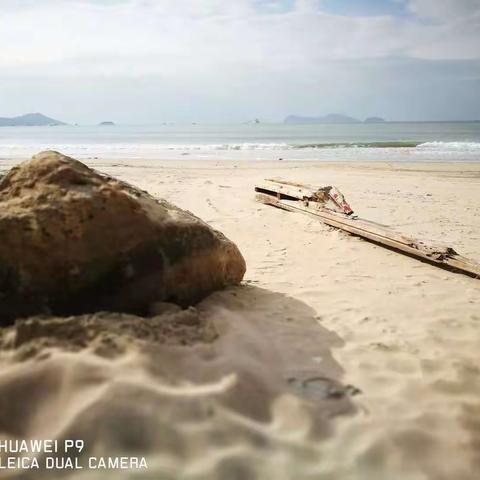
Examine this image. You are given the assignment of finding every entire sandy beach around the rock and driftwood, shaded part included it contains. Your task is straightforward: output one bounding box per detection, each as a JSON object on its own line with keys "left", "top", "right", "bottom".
{"left": 0, "top": 160, "right": 480, "bottom": 480}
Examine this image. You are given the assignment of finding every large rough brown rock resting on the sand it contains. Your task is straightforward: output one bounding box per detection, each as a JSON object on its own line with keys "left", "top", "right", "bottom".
{"left": 0, "top": 152, "right": 245, "bottom": 324}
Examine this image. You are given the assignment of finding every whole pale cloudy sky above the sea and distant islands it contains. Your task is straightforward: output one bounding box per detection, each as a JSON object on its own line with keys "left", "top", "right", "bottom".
{"left": 0, "top": 0, "right": 480, "bottom": 123}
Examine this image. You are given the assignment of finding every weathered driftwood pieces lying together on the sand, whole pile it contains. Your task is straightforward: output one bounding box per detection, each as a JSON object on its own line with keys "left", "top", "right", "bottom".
{"left": 255, "top": 180, "right": 480, "bottom": 278}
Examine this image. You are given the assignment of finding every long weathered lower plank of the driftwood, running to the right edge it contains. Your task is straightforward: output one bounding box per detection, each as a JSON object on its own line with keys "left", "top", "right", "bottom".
{"left": 256, "top": 193, "right": 480, "bottom": 278}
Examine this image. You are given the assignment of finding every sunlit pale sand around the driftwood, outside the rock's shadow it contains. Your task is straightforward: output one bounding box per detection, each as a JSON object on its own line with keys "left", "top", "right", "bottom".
{"left": 0, "top": 160, "right": 480, "bottom": 480}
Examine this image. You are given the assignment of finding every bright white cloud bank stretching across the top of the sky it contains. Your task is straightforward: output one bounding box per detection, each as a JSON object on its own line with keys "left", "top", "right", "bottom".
{"left": 0, "top": 0, "right": 480, "bottom": 74}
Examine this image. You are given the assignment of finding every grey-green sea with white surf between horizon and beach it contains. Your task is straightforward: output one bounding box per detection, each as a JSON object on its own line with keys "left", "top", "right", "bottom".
{"left": 0, "top": 122, "right": 480, "bottom": 162}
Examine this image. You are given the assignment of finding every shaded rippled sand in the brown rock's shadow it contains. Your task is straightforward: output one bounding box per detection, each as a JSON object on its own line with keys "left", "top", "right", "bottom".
{"left": 0, "top": 286, "right": 352, "bottom": 480}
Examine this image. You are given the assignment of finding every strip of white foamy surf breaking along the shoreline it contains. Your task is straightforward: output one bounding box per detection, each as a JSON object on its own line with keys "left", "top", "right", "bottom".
{"left": 0, "top": 141, "right": 480, "bottom": 162}
